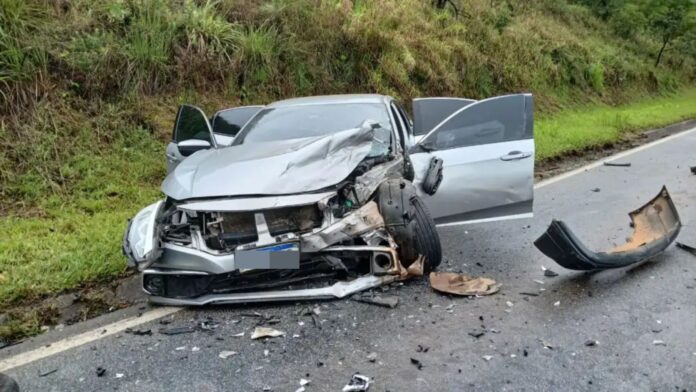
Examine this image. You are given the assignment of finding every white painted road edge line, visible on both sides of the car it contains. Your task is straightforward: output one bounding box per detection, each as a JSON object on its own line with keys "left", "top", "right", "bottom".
{"left": 0, "top": 128, "right": 696, "bottom": 372}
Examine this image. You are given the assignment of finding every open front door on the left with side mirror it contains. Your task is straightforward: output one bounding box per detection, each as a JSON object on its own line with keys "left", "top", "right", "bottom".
{"left": 166, "top": 105, "right": 217, "bottom": 173}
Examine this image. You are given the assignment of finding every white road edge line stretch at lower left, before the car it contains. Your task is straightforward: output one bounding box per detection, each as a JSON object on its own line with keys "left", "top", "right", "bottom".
{"left": 0, "top": 307, "right": 182, "bottom": 372}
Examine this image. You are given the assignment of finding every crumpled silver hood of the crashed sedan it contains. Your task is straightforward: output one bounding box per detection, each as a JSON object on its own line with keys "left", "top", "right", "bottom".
{"left": 162, "top": 126, "right": 374, "bottom": 200}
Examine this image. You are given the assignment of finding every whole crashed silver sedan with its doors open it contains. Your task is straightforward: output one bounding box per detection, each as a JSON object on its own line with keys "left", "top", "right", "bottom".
{"left": 123, "top": 94, "right": 534, "bottom": 305}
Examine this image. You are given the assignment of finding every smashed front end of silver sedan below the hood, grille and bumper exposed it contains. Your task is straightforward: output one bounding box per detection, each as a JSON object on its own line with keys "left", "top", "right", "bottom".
{"left": 124, "top": 159, "right": 423, "bottom": 305}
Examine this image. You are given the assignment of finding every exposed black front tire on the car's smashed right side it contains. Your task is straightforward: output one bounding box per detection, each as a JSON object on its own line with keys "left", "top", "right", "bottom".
{"left": 377, "top": 180, "right": 442, "bottom": 273}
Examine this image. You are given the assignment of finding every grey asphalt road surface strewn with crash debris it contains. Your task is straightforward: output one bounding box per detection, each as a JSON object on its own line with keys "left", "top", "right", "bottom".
{"left": 0, "top": 130, "right": 696, "bottom": 391}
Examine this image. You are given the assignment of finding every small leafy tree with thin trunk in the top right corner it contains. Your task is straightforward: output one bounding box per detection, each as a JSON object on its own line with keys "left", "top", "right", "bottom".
{"left": 645, "top": 0, "right": 695, "bottom": 67}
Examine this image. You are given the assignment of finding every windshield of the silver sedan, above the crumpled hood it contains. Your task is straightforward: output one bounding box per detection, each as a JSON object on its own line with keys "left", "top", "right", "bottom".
{"left": 234, "top": 103, "right": 391, "bottom": 144}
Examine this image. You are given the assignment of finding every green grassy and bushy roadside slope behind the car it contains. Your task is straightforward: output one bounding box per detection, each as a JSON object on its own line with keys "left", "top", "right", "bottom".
{"left": 0, "top": 0, "right": 696, "bottom": 338}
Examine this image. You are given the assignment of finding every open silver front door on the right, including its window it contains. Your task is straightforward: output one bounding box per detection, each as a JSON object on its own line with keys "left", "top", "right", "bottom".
{"left": 410, "top": 94, "right": 534, "bottom": 225}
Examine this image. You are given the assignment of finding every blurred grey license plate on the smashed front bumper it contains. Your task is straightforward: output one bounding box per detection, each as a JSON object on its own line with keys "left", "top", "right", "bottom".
{"left": 234, "top": 242, "right": 300, "bottom": 269}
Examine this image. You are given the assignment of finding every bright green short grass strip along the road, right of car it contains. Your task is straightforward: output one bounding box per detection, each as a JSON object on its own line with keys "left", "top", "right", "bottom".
{"left": 534, "top": 88, "right": 696, "bottom": 161}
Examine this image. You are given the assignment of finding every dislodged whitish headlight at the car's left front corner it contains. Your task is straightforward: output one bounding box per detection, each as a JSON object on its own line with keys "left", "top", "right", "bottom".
{"left": 123, "top": 200, "right": 164, "bottom": 270}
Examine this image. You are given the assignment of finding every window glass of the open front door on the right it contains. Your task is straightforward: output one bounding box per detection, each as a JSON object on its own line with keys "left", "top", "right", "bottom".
{"left": 421, "top": 94, "right": 532, "bottom": 150}
